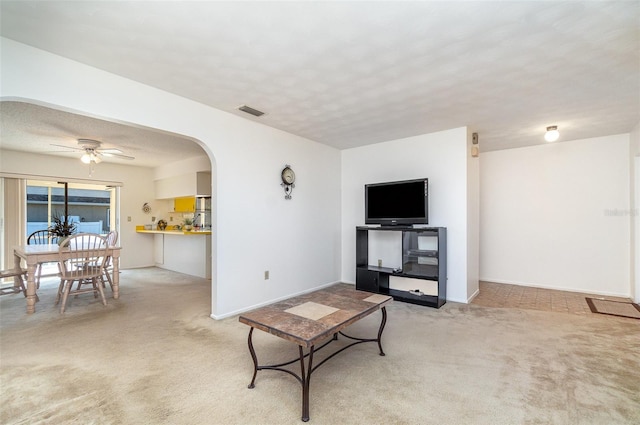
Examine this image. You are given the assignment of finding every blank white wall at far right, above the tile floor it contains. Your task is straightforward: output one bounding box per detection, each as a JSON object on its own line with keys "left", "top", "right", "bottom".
{"left": 480, "top": 135, "right": 630, "bottom": 296}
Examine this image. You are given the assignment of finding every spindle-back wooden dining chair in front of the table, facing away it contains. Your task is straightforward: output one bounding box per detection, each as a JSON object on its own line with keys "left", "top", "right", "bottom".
{"left": 56, "top": 233, "right": 107, "bottom": 313}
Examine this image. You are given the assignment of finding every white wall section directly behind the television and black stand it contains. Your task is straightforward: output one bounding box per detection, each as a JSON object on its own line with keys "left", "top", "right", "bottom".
{"left": 342, "top": 127, "right": 477, "bottom": 302}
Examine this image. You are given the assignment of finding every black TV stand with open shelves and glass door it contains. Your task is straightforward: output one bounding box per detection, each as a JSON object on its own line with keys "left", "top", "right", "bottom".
{"left": 356, "top": 225, "right": 447, "bottom": 308}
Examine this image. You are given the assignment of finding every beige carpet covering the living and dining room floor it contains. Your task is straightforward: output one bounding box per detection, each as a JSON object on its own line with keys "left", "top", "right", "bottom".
{"left": 0, "top": 268, "right": 640, "bottom": 425}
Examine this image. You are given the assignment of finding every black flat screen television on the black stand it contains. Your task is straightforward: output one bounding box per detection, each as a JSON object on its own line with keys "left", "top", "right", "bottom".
{"left": 364, "top": 178, "right": 429, "bottom": 226}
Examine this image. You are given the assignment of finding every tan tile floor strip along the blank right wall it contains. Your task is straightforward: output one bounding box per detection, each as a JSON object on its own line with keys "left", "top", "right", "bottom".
{"left": 471, "top": 282, "right": 630, "bottom": 314}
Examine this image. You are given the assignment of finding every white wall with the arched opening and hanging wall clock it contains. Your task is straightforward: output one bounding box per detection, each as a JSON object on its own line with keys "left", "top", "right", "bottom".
{"left": 0, "top": 38, "right": 341, "bottom": 318}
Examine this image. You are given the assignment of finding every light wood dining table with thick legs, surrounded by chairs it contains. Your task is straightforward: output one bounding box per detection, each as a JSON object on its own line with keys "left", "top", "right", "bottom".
{"left": 13, "top": 244, "right": 121, "bottom": 314}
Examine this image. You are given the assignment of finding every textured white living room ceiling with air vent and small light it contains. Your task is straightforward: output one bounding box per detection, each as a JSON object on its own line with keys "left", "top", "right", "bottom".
{"left": 0, "top": 1, "right": 640, "bottom": 162}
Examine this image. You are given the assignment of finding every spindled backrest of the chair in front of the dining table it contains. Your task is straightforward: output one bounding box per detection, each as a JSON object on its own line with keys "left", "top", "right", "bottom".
{"left": 59, "top": 233, "right": 107, "bottom": 279}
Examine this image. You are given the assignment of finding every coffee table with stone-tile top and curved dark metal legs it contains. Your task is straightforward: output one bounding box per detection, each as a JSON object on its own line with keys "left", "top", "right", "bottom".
{"left": 239, "top": 284, "right": 392, "bottom": 422}
